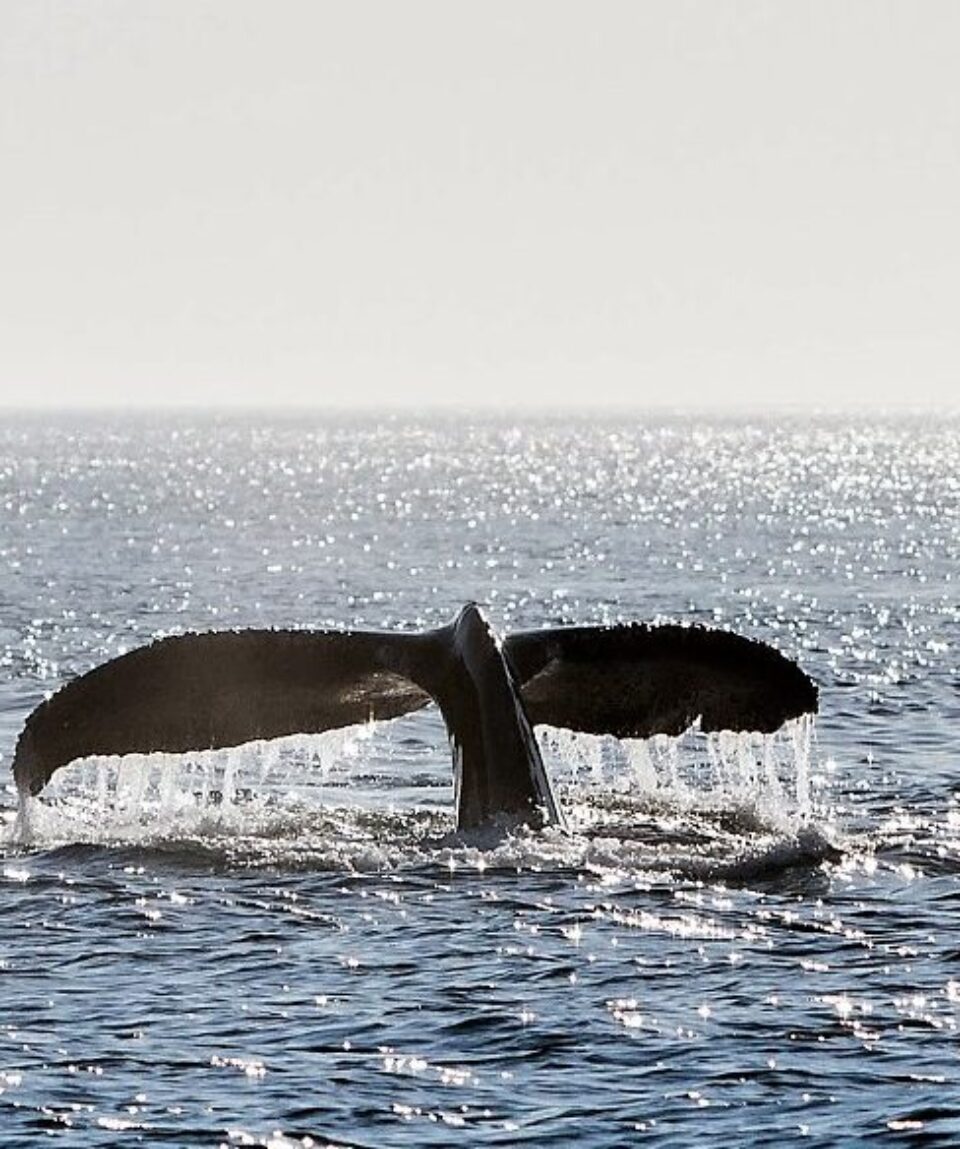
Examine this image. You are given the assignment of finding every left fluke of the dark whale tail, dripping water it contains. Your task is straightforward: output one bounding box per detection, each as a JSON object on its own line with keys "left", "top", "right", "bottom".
{"left": 7, "top": 630, "right": 431, "bottom": 794}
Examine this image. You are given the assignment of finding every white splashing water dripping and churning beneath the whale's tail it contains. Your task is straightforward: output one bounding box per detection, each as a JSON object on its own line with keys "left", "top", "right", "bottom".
{"left": 3, "top": 719, "right": 833, "bottom": 874}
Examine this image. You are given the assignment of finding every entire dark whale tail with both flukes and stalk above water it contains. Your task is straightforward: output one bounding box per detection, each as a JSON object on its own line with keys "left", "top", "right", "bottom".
{"left": 13, "top": 603, "right": 816, "bottom": 827}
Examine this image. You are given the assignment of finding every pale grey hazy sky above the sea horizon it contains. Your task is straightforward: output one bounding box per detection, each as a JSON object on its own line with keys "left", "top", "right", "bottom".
{"left": 0, "top": 0, "right": 960, "bottom": 406}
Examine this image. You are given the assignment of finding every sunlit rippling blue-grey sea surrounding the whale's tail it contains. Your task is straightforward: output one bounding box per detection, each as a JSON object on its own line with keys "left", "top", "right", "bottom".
{"left": 0, "top": 416, "right": 960, "bottom": 1147}
